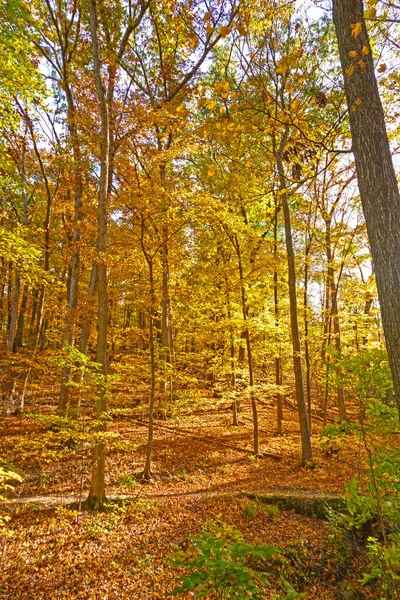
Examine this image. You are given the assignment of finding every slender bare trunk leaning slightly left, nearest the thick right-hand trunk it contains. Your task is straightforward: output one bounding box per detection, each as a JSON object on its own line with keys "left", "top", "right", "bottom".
{"left": 274, "top": 131, "right": 312, "bottom": 464}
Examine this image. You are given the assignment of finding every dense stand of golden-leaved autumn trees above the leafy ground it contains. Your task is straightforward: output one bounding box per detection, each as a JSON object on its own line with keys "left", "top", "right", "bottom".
{"left": 0, "top": 0, "right": 397, "bottom": 507}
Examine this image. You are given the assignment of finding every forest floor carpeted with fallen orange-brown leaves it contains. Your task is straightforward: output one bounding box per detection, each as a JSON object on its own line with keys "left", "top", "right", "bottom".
{"left": 0, "top": 384, "right": 373, "bottom": 600}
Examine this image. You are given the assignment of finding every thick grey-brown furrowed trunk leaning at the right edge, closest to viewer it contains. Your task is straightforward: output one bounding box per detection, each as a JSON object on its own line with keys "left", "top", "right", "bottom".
{"left": 333, "top": 0, "right": 400, "bottom": 418}
